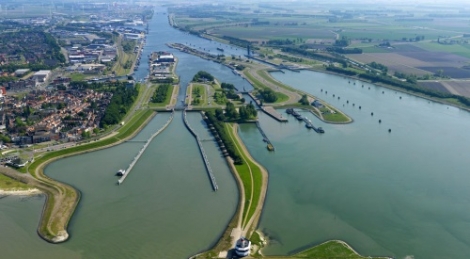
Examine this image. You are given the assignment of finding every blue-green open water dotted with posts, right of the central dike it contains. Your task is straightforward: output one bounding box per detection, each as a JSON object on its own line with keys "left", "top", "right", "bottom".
{"left": 240, "top": 72, "right": 470, "bottom": 258}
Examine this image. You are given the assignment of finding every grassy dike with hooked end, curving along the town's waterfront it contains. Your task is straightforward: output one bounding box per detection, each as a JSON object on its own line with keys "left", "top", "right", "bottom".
{"left": 27, "top": 110, "right": 155, "bottom": 243}
